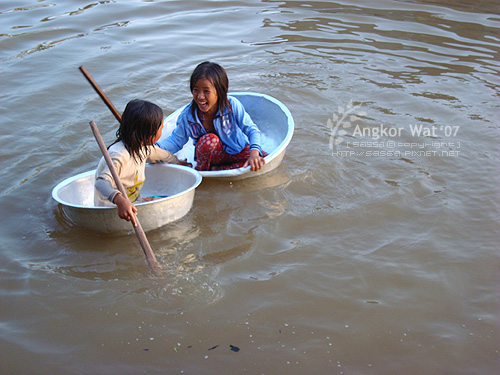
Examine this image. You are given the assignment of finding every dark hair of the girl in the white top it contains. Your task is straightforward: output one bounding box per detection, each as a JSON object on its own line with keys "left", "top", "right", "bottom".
{"left": 113, "top": 99, "right": 163, "bottom": 162}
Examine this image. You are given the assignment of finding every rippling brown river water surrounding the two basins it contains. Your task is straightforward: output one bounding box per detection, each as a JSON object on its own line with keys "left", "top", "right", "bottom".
{"left": 0, "top": 0, "right": 500, "bottom": 375}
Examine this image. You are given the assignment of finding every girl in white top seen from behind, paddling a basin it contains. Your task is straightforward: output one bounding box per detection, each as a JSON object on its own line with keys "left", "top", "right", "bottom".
{"left": 94, "top": 99, "right": 190, "bottom": 225}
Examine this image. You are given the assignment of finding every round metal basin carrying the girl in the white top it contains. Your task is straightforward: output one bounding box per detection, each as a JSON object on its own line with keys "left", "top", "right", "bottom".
{"left": 52, "top": 164, "right": 202, "bottom": 233}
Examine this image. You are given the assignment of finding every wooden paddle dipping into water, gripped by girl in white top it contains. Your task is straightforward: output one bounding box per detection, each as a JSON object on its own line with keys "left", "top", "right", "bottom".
{"left": 90, "top": 121, "right": 161, "bottom": 276}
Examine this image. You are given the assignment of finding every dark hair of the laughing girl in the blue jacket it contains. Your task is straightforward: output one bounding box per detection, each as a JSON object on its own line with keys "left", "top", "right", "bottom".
{"left": 189, "top": 61, "right": 231, "bottom": 113}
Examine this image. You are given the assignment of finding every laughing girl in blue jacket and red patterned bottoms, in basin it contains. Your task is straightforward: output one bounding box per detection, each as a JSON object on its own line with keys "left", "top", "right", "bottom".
{"left": 158, "top": 61, "right": 267, "bottom": 171}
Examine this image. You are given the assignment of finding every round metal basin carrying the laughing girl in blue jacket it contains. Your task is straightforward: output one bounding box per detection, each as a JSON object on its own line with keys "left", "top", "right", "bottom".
{"left": 160, "top": 92, "right": 294, "bottom": 180}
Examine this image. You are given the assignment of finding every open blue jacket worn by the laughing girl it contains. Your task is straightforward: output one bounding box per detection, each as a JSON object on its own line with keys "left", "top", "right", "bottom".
{"left": 157, "top": 96, "right": 262, "bottom": 155}
